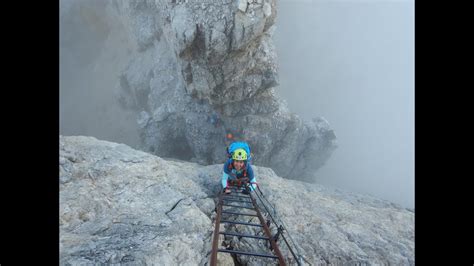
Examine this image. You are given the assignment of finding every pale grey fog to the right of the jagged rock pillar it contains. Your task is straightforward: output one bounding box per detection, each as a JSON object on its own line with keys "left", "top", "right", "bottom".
{"left": 274, "top": 0, "right": 414, "bottom": 208}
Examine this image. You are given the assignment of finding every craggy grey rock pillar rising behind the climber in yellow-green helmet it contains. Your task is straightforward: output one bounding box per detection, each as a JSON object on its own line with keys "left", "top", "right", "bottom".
{"left": 60, "top": 0, "right": 336, "bottom": 181}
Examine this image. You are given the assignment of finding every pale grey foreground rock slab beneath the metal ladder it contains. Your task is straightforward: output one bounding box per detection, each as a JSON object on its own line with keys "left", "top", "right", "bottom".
{"left": 59, "top": 136, "right": 414, "bottom": 265}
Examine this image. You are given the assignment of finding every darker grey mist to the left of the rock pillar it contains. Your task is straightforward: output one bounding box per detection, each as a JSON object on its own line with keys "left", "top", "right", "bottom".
{"left": 59, "top": 0, "right": 140, "bottom": 148}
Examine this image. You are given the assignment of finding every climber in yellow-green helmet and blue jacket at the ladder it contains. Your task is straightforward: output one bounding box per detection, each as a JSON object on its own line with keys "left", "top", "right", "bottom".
{"left": 221, "top": 148, "right": 257, "bottom": 194}
